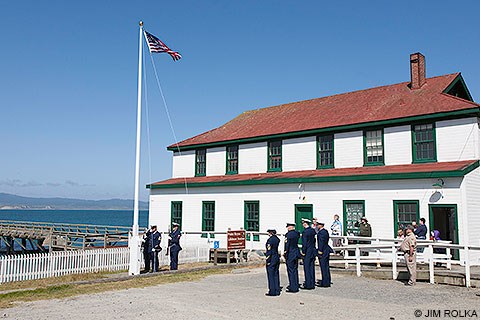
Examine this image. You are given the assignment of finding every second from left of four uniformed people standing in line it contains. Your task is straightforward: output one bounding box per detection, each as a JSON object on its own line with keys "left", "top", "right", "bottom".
{"left": 283, "top": 223, "right": 300, "bottom": 293}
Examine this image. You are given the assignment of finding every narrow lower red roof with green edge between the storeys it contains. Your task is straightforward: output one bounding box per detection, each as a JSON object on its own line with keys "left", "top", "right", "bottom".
{"left": 150, "top": 160, "right": 479, "bottom": 189}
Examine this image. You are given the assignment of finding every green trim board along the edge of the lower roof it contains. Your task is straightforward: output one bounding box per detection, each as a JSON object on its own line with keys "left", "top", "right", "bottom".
{"left": 147, "top": 160, "right": 479, "bottom": 189}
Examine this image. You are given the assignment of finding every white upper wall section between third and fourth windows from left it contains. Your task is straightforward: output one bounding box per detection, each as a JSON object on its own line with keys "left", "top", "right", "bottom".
{"left": 282, "top": 136, "right": 317, "bottom": 171}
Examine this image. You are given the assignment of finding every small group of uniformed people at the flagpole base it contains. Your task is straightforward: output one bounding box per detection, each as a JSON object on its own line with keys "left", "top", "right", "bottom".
{"left": 143, "top": 223, "right": 182, "bottom": 272}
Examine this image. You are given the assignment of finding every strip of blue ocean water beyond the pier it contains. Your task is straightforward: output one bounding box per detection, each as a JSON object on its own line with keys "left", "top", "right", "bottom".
{"left": 0, "top": 210, "right": 148, "bottom": 228}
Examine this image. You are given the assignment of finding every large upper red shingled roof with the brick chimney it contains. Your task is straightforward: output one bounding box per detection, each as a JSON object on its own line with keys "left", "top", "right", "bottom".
{"left": 169, "top": 73, "right": 480, "bottom": 148}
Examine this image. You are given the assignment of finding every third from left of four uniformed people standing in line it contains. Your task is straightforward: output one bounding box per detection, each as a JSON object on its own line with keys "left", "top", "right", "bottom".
{"left": 300, "top": 219, "right": 317, "bottom": 290}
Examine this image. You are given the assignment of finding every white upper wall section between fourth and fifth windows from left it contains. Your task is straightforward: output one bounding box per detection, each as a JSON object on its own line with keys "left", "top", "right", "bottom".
{"left": 333, "top": 131, "right": 363, "bottom": 168}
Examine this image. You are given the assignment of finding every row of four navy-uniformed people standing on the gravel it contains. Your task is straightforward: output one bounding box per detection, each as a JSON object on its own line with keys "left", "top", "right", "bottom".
{"left": 265, "top": 219, "right": 333, "bottom": 296}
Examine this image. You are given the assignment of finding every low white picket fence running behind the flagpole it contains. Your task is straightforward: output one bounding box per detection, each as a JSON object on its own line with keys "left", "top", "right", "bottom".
{"left": 0, "top": 246, "right": 209, "bottom": 283}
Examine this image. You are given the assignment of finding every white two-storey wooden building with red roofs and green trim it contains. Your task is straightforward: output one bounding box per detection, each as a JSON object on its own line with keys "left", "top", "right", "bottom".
{"left": 147, "top": 53, "right": 480, "bottom": 259}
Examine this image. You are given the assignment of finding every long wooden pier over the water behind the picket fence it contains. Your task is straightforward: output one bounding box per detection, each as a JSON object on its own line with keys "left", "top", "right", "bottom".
{"left": 0, "top": 220, "right": 131, "bottom": 254}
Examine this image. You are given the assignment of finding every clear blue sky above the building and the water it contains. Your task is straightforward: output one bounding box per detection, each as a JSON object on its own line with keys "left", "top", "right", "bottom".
{"left": 0, "top": 0, "right": 480, "bottom": 200}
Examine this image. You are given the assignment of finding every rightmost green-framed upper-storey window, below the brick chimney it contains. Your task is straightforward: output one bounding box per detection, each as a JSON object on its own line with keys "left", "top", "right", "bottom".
{"left": 412, "top": 123, "right": 437, "bottom": 163}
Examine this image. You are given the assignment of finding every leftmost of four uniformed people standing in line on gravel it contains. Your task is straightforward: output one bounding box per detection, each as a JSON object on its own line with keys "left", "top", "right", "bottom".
{"left": 265, "top": 229, "right": 280, "bottom": 296}
